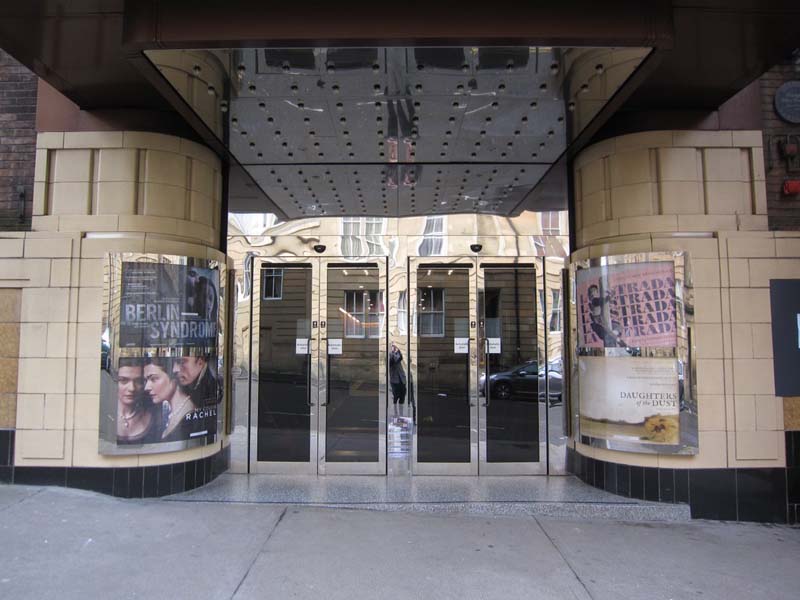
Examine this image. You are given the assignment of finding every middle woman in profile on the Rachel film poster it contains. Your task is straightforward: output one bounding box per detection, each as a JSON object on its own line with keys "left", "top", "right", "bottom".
{"left": 144, "top": 357, "right": 197, "bottom": 442}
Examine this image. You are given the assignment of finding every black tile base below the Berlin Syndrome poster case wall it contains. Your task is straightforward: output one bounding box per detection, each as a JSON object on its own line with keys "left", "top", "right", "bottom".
{"left": 0, "top": 446, "right": 231, "bottom": 498}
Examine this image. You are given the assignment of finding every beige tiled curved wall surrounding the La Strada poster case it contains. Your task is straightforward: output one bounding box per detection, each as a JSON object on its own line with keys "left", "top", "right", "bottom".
{"left": 572, "top": 131, "right": 800, "bottom": 468}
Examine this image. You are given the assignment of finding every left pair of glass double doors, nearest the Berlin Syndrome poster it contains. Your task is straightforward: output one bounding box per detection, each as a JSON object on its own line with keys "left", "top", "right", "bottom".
{"left": 249, "top": 258, "right": 386, "bottom": 474}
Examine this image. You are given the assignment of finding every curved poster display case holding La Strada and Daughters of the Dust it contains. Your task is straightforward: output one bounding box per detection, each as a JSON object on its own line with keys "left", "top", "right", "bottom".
{"left": 570, "top": 252, "right": 698, "bottom": 454}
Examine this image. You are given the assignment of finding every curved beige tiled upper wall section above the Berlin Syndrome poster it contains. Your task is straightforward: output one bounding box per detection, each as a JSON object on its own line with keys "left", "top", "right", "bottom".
{"left": 33, "top": 131, "right": 222, "bottom": 246}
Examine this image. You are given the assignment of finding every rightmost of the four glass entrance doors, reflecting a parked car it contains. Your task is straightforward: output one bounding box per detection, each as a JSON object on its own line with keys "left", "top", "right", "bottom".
{"left": 478, "top": 261, "right": 547, "bottom": 475}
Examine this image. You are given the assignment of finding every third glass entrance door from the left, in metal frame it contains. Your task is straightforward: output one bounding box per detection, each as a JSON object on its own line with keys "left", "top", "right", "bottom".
{"left": 409, "top": 259, "right": 478, "bottom": 475}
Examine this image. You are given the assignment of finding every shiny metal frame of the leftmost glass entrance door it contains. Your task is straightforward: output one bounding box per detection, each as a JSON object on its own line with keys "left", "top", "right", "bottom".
{"left": 249, "top": 257, "right": 320, "bottom": 475}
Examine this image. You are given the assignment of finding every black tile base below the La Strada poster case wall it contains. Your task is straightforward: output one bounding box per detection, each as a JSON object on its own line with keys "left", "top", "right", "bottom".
{"left": 567, "top": 446, "right": 800, "bottom": 524}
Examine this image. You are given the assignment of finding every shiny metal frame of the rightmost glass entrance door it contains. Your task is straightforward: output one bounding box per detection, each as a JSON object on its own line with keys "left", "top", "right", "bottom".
{"left": 476, "top": 257, "right": 548, "bottom": 475}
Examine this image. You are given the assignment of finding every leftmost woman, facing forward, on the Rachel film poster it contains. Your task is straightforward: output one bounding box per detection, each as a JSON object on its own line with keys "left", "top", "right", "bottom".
{"left": 117, "top": 358, "right": 161, "bottom": 444}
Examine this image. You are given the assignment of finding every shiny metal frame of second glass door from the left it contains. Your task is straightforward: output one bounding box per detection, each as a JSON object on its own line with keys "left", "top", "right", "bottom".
{"left": 317, "top": 256, "right": 389, "bottom": 475}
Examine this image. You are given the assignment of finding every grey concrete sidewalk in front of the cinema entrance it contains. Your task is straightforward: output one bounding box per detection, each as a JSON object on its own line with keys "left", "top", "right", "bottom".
{"left": 0, "top": 485, "right": 800, "bottom": 600}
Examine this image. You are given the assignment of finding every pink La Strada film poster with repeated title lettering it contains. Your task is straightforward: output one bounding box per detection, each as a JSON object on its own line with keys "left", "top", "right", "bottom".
{"left": 576, "top": 261, "right": 677, "bottom": 348}
